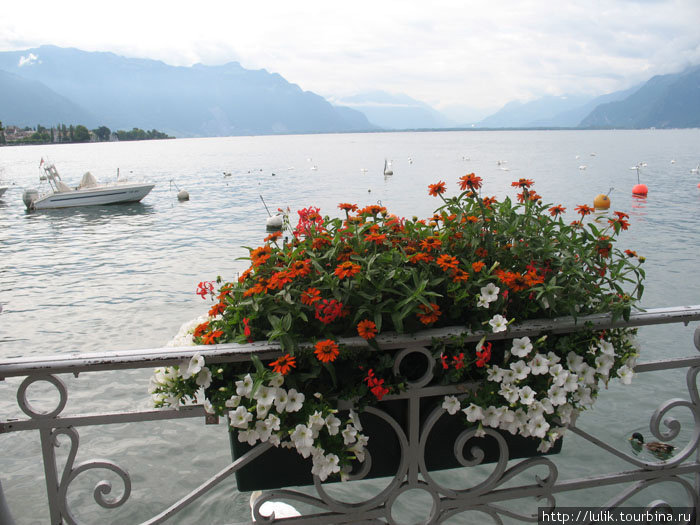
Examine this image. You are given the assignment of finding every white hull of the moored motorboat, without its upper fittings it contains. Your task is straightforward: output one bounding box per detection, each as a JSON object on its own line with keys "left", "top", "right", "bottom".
{"left": 32, "top": 184, "right": 155, "bottom": 210}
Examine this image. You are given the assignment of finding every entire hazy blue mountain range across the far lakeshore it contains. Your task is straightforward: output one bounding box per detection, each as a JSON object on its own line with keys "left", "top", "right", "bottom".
{"left": 0, "top": 46, "right": 700, "bottom": 137}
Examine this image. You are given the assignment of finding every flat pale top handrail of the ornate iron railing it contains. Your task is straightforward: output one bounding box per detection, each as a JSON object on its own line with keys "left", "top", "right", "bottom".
{"left": 0, "top": 305, "right": 700, "bottom": 380}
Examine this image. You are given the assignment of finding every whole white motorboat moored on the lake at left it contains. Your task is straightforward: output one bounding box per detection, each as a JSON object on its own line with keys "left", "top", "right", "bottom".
{"left": 22, "top": 159, "right": 155, "bottom": 211}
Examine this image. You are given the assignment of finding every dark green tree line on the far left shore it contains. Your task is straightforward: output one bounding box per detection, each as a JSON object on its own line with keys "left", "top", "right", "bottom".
{"left": 0, "top": 121, "right": 174, "bottom": 144}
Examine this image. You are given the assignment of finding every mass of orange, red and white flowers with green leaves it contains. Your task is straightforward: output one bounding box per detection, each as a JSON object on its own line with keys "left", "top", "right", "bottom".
{"left": 151, "top": 174, "right": 644, "bottom": 479}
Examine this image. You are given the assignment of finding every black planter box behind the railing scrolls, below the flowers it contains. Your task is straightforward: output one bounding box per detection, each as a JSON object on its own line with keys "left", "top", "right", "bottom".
{"left": 229, "top": 396, "right": 562, "bottom": 492}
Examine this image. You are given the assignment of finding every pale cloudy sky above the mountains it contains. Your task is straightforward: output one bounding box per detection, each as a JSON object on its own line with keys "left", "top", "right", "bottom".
{"left": 0, "top": 0, "right": 700, "bottom": 115}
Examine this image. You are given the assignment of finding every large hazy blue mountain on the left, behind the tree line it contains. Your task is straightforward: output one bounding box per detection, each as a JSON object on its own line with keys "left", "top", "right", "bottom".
{"left": 0, "top": 46, "right": 375, "bottom": 137}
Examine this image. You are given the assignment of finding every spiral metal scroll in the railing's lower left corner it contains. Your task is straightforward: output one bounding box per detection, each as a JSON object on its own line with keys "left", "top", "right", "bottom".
{"left": 51, "top": 427, "right": 131, "bottom": 525}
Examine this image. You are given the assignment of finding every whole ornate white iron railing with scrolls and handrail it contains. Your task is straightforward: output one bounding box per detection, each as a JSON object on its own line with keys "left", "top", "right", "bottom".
{"left": 0, "top": 306, "right": 700, "bottom": 524}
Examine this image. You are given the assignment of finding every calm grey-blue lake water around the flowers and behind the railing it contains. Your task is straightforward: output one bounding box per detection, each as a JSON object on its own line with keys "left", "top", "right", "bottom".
{"left": 0, "top": 130, "right": 700, "bottom": 524}
